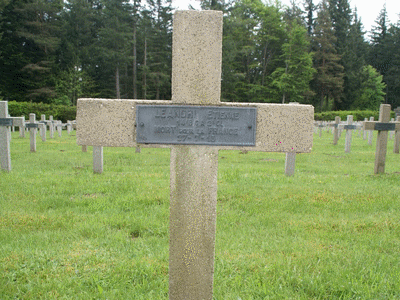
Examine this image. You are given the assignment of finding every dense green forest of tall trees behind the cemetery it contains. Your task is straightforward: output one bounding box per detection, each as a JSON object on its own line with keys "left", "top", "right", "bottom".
{"left": 0, "top": 0, "right": 400, "bottom": 111}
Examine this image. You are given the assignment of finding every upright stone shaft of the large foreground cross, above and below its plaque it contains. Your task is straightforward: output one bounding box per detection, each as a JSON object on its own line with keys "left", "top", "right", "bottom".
{"left": 169, "top": 11, "right": 222, "bottom": 300}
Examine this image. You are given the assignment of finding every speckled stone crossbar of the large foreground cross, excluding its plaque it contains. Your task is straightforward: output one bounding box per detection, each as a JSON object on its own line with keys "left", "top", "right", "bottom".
{"left": 76, "top": 99, "right": 314, "bottom": 153}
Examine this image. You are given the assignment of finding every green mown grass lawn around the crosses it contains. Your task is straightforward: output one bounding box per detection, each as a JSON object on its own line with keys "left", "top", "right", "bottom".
{"left": 0, "top": 131, "right": 400, "bottom": 300}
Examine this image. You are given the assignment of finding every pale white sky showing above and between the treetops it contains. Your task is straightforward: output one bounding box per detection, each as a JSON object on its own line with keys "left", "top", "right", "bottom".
{"left": 172, "top": 0, "right": 400, "bottom": 36}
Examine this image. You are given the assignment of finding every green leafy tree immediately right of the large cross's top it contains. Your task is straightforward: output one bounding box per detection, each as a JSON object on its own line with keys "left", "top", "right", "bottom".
{"left": 222, "top": 0, "right": 287, "bottom": 102}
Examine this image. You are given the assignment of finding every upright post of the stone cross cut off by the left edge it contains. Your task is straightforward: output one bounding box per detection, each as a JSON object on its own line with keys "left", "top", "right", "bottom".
{"left": 0, "top": 101, "right": 11, "bottom": 172}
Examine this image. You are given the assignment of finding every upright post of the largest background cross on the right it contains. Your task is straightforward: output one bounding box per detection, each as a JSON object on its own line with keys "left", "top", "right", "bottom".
{"left": 374, "top": 104, "right": 390, "bottom": 174}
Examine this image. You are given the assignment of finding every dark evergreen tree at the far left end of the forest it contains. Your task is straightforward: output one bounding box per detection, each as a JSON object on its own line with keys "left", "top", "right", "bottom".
{"left": 0, "top": 0, "right": 63, "bottom": 102}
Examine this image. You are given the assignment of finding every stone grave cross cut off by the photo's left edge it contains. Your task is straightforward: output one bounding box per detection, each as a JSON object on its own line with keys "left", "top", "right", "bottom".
{"left": 0, "top": 101, "right": 24, "bottom": 172}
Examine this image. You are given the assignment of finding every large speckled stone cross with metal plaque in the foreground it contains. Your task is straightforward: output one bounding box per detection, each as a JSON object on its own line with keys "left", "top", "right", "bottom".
{"left": 76, "top": 11, "right": 314, "bottom": 300}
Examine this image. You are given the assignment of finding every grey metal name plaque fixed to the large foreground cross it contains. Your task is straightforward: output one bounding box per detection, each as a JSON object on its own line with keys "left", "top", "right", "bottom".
{"left": 136, "top": 105, "right": 257, "bottom": 146}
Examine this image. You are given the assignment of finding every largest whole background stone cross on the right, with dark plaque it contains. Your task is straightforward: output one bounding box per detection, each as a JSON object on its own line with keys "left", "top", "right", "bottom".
{"left": 364, "top": 104, "right": 400, "bottom": 174}
